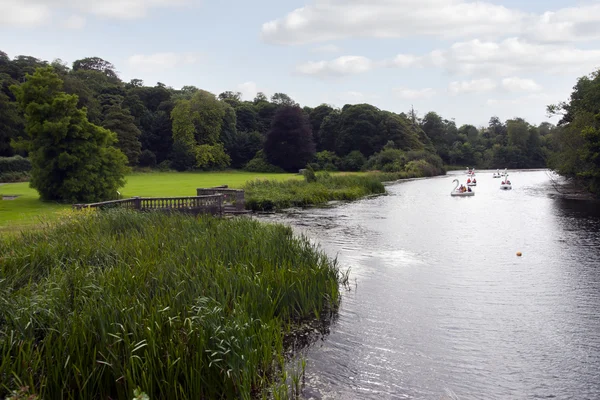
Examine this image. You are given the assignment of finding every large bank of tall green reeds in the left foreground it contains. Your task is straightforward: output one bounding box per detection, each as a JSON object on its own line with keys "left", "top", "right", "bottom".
{"left": 0, "top": 210, "right": 340, "bottom": 400}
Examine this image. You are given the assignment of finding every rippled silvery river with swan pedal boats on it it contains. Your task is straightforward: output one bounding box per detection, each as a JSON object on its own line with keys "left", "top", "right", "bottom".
{"left": 264, "top": 171, "right": 600, "bottom": 400}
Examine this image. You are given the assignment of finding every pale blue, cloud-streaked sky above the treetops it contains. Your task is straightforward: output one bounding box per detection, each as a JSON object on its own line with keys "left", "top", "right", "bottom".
{"left": 0, "top": 0, "right": 600, "bottom": 126}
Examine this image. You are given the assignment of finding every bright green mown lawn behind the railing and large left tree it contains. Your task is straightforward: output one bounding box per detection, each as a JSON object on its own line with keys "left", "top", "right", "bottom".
{"left": 0, "top": 171, "right": 301, "bottom": 232}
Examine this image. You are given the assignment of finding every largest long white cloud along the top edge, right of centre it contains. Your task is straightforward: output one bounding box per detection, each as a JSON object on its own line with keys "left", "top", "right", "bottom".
{"left": 262, "top": 0, "right": 527, "bottom": 44}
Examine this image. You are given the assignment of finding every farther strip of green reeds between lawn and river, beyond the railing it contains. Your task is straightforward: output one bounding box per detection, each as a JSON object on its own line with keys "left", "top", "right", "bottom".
{"left": 244, "top": 173, "right": 385, "bottom": 211}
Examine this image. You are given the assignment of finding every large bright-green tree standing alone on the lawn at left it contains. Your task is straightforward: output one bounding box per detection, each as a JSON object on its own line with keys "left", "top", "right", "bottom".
{"left": 11, "top": 67, "right": 127, "bottom": 202}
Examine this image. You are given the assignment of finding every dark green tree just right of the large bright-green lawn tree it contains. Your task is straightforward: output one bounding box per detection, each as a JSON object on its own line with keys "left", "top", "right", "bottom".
{"left": 102, "top": 104, "right": 142, "bottom": 166}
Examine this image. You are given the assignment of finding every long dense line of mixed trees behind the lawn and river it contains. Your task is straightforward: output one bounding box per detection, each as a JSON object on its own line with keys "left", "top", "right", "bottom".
{"left": 0, "top": 52, "right": 584, "bottom": 200}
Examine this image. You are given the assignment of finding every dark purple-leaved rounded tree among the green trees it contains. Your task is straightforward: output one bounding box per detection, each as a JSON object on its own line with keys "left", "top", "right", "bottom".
{"left": 265, "top": 106, "right": 315, "bottom": 171}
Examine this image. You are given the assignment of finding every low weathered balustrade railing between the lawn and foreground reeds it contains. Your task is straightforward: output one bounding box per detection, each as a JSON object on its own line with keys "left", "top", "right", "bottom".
{"left": 73, "top": 194, "right": 224, "bottom": 215}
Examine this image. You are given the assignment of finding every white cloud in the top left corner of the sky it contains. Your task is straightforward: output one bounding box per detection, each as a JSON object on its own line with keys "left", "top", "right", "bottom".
{"left": 0, "top": 0, "right": 191, "bottom": 28}
